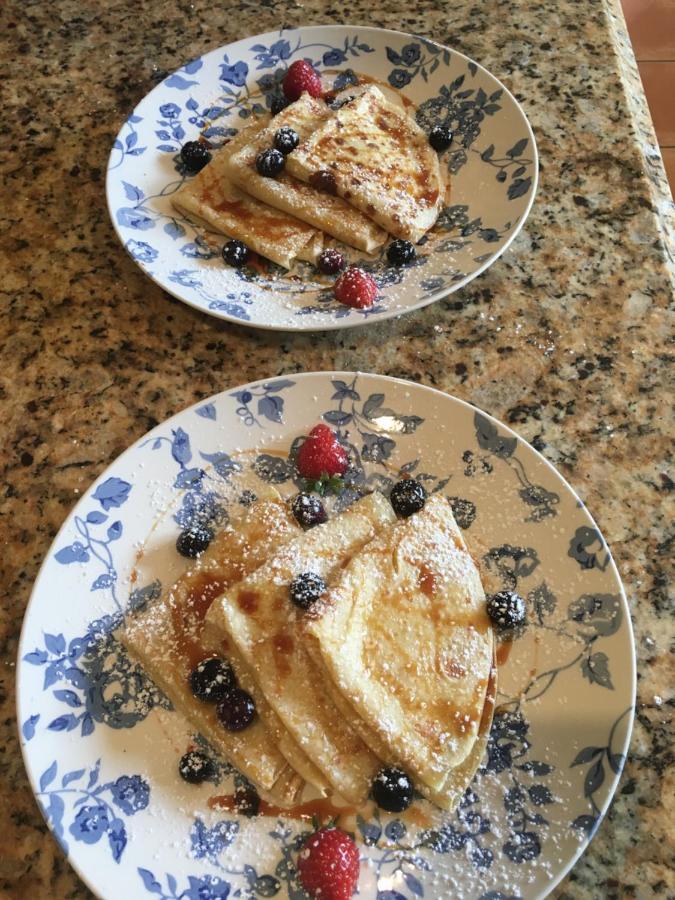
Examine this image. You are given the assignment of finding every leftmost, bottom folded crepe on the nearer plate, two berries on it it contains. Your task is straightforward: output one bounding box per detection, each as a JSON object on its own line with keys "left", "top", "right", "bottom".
{"left": 118, "top": 489, "right": 304, "bottom": 803}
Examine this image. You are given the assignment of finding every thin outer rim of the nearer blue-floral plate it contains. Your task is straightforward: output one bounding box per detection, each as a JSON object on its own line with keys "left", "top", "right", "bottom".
{"left": 14, "top": 369, "right": 637, "bottom": 900}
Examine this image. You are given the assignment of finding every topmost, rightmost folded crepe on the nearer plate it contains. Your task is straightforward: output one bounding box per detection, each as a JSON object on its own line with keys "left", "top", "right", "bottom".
{"left": 304, "top": 496, "right": 493, "bottom": 793}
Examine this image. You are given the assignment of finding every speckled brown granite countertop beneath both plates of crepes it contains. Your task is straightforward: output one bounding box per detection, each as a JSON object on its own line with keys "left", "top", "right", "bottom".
{"left": 0, "top": 0, "right": 675, "bottom": 900}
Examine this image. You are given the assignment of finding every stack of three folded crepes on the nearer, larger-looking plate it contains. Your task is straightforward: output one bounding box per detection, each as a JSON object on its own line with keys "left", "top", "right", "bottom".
{"left": 117, "top": 492, "right": 494, "bottom": 809}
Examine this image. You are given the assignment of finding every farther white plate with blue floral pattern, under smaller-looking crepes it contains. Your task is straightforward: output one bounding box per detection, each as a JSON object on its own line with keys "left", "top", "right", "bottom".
{"left": 107, "top": 25, "right": 537, "bottom": 331}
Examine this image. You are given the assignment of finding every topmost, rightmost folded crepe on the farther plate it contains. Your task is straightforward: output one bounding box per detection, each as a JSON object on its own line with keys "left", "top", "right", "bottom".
{"left": 286, "top": 85, "right": 446, "bottom": 241}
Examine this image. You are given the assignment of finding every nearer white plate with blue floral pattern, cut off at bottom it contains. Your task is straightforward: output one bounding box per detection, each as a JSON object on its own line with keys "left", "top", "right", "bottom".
{"left": 17, "top": 373, "right": 635, "bottom": 900}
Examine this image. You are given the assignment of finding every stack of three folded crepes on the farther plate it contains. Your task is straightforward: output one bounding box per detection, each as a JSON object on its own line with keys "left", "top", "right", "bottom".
{"left": 172, "top": 85, "right": 446, "bottom": 268}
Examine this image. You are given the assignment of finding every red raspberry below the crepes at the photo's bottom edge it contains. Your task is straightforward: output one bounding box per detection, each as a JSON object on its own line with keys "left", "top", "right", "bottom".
{"left": 298, "top": 828, "right": 359, "bottom": 900}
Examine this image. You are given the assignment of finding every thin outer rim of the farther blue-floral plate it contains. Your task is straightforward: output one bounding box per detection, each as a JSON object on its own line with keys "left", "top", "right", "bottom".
{"left": 105, "top": 23, "right": 539, "bottom": 333}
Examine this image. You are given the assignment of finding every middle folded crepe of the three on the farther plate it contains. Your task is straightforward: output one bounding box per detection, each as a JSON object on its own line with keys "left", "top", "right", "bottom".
{"left": 224, "top": 93, "right": 387, "bottom": 253}
